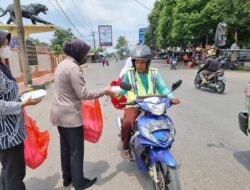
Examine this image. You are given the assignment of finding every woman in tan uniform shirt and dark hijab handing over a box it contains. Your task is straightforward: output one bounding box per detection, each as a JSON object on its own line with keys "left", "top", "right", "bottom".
{"left": 50, "top": 39, "right": 112, "bottom": 190}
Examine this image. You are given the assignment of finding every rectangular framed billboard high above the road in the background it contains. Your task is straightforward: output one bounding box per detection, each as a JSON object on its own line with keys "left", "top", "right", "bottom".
{"left": 98, "top": 25, "right": 112, "bottom": 46}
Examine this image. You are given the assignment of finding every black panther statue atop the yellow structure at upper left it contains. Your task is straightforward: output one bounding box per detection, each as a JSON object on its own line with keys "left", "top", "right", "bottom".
{"left": 0, "top": 3, "right": 51, "bottom": 24}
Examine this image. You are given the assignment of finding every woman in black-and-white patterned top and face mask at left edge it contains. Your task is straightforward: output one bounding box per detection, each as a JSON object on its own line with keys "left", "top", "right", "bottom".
{"left": 0, "top": 31, "right": 40, "bottom": 190}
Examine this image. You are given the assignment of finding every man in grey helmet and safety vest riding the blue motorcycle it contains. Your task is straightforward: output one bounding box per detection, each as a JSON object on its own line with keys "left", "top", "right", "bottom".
{"left": 113, "top": 45, "right": 180, "bottom": 159}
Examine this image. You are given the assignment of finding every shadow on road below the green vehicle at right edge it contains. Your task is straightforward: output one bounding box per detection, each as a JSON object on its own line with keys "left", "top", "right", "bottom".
{"left": 207, "top": 143, "right": 250, "bottom": 171}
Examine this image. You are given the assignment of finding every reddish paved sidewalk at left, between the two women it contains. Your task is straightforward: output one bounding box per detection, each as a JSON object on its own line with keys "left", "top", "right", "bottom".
{"left": 18, "top": 73, "right": 54, "bottom": 94}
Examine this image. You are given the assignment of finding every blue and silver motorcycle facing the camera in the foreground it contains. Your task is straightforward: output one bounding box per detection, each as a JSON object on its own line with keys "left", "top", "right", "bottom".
{"left": 117, "top": 80, "right": 182, "bottom": 190}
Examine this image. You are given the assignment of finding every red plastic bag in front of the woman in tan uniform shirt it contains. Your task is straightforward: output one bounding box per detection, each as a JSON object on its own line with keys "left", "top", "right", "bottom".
{"left": 82, "top": 99, "right": 103, "bottom": 143}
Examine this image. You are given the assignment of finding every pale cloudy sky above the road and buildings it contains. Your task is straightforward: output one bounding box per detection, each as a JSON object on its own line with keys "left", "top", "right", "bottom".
{"left": 0, "top": 0, "right": 156, "bottom": 51}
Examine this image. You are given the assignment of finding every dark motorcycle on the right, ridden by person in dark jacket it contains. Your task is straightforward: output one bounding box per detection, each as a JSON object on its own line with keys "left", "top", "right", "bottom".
{"left": 194, "top": 66, "right": 226, "bottom": 94}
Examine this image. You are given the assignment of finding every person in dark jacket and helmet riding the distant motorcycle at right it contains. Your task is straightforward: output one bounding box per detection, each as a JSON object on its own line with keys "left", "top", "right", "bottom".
{"left": 200, "top": 48, "right": 219, "bottom": 85}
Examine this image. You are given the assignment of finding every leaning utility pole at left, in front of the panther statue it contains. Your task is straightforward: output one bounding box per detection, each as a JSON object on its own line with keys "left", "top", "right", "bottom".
{"left": 13, "top": 0, "right": 32, "bottom": 86}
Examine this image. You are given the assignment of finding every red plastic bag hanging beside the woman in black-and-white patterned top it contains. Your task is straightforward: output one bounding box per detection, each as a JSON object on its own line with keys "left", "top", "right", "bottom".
{"left": 23, "top": 110, "right": 50, "bottom": 169}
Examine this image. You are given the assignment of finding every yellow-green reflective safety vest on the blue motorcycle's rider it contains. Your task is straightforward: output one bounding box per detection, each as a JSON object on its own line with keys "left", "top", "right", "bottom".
{"left": 127, "top": 68, "right": 159, "bottom": 102}
